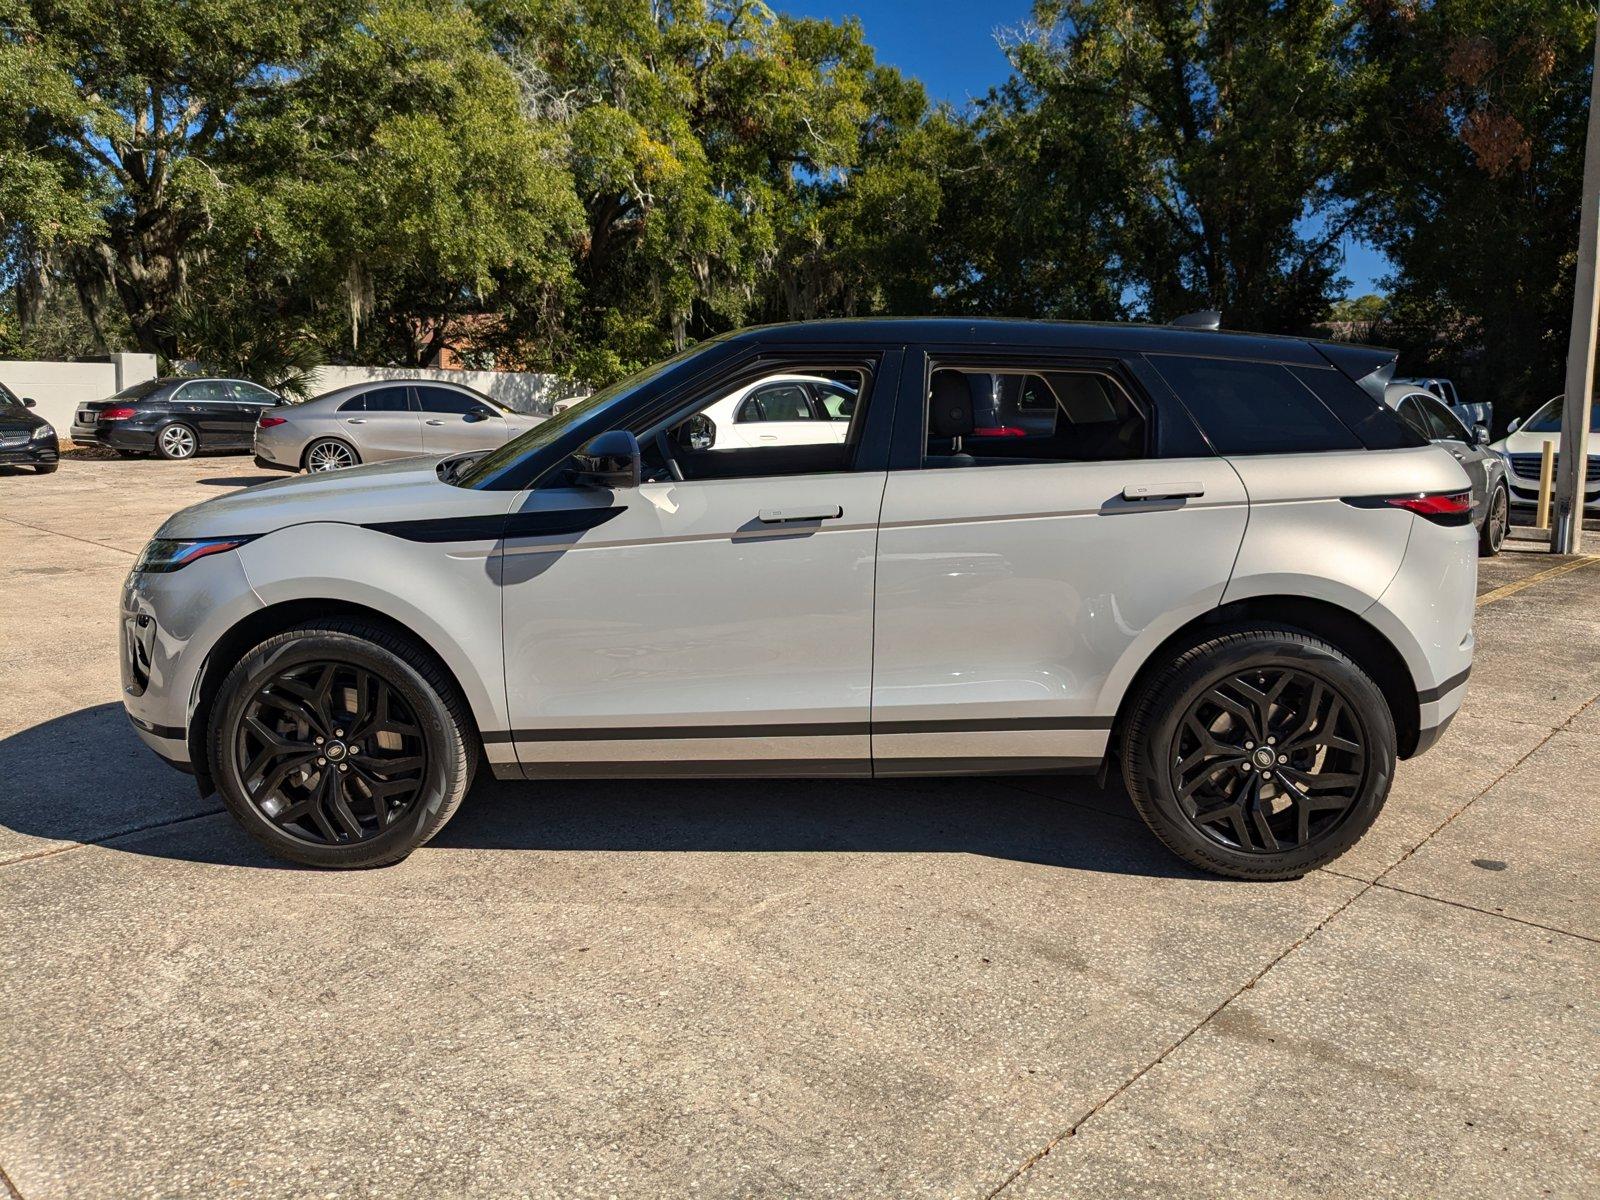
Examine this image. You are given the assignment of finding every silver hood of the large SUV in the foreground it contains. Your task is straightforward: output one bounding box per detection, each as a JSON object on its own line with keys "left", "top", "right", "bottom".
{"left": 157, "top": 456, "right": 510, "bottom": 538}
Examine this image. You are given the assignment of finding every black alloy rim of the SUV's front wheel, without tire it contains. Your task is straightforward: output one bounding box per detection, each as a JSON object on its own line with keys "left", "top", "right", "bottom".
{"left": 234, "top": 661, "right": 427, "bottom": 846}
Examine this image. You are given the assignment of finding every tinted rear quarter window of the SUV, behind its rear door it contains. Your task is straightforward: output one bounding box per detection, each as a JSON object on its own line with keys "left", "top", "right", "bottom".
{"left": 1150, "top": 354, "right": 1365, "bottom": 454}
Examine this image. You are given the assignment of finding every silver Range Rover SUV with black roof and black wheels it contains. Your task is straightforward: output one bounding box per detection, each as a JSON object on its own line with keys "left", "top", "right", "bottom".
{"left": 122, "top": 320, "right": 1477, "bottom": 878}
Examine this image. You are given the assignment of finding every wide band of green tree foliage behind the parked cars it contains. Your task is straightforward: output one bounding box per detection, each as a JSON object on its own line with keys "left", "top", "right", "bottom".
{"left": 0, "top": 0, "right": 1592, "bottom": 410}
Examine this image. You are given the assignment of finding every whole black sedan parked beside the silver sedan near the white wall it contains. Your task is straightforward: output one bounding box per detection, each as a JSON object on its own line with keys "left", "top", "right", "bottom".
{"left": 72, "top": 376, "right": 283, "bottom": 459}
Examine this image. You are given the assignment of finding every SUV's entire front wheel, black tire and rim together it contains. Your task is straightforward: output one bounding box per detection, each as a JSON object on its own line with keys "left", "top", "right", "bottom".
{"left": 206, "top": 619, "right": 478, "bottom": 867}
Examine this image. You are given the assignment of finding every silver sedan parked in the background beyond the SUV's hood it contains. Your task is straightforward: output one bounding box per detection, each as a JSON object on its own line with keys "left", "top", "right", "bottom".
{"left": 254, "top": 379, "right": 539, "bottom": 472}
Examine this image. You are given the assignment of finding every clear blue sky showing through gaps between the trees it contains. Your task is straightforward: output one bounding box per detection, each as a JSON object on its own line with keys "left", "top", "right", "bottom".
{"left": 773, "top": 0, "right": 1389, "bottom": 296}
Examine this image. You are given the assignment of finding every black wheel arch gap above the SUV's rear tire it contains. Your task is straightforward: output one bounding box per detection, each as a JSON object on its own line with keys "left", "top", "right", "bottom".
{"left": 1101, "top": 595, "right": 1421, "bottom": 778}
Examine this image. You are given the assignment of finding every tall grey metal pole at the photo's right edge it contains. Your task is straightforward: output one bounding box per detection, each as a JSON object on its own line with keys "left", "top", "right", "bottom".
{"left": 1550, "top": 10, "right": 1600, "bottom": 554}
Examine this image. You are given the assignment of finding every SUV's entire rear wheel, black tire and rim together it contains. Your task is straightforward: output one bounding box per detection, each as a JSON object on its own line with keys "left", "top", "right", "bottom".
{"left": 1122, "top": 626, "right": 1395, "bottom": 880}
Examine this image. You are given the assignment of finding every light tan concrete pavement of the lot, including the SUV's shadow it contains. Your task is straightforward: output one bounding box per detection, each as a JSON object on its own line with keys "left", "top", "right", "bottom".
{"left": 0, "top": 458, "right": 1600, "bottom": 1200}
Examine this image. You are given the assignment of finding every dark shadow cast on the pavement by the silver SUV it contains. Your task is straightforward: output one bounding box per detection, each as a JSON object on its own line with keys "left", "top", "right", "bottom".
{"left": 0, "top": 704, "right": 1198, "bottom": 877}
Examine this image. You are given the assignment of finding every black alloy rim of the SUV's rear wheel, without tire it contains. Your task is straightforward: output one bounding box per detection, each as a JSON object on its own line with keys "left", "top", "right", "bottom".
{"left": 1171, "top": 667, "right": 1366, "bottom": 854}
